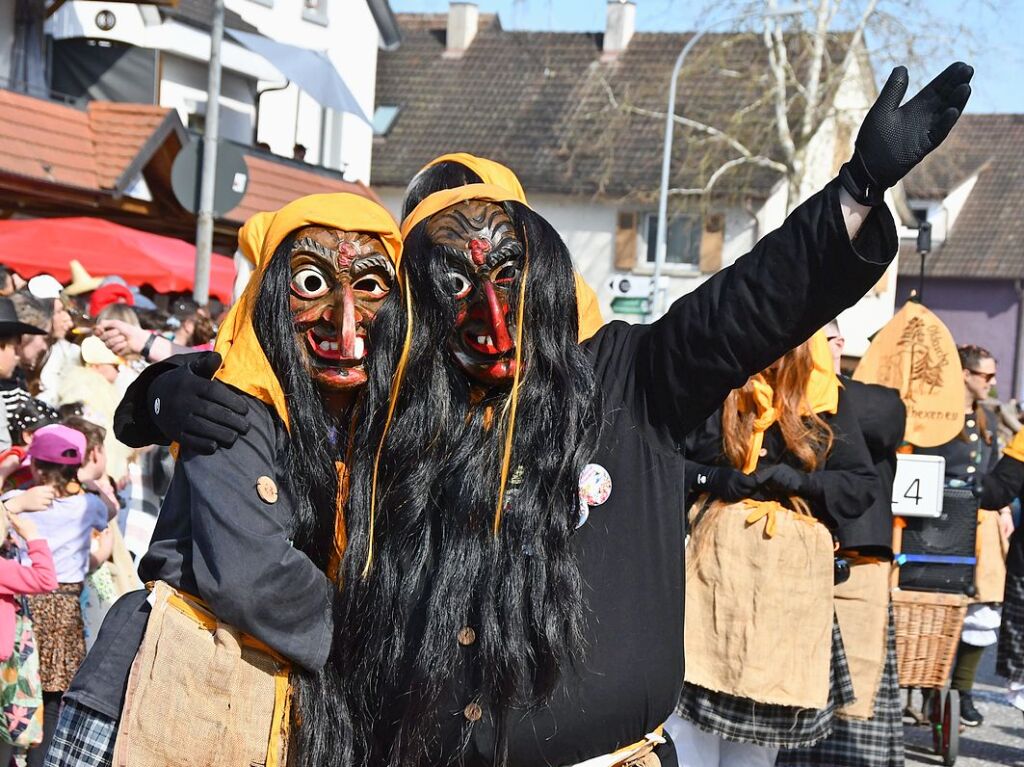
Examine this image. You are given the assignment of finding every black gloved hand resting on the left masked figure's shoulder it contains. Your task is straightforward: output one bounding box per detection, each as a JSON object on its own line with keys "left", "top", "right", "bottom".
{"left": 147, "top": 351, "right": 249, "bottom": 456}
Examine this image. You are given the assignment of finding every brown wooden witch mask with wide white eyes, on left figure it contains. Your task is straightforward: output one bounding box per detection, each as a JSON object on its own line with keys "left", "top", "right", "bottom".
{"left": 290, "top": 226, "right": 394, "bottom": 389}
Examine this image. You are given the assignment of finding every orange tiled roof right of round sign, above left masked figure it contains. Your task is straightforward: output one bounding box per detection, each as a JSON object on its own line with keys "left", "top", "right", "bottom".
{"left": 224, "top": 155, "right": 380, "bottom": 222}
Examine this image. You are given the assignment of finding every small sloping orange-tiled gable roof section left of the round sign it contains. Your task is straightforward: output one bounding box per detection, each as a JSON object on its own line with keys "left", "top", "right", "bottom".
{"left": 88, "top": 101, "right": 177, "bottom": 188}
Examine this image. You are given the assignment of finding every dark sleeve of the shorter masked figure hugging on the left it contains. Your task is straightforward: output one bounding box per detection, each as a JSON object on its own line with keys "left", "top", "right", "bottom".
{"left": 178, "top": 406, "right": 333, "bottom": 671}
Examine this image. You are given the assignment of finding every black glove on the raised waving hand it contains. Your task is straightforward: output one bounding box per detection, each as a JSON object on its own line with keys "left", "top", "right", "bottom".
{"left": 839, "top": 61, "right": 974, "bottom": 205}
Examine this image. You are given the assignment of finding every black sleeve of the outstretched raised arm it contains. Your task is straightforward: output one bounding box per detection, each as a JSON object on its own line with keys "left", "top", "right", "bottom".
{"left": 634, "top": 181, "right": 898, "bottom": 444}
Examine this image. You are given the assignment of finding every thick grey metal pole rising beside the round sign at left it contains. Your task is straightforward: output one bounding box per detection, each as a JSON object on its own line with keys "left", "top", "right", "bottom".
{"left": 193, "top": 0, "right": 224, "bottom": 306}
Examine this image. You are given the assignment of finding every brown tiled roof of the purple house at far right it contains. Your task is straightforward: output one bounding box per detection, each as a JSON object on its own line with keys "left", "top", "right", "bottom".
{"left": 900, "top": 115, "right": 1024, "bottom": 280}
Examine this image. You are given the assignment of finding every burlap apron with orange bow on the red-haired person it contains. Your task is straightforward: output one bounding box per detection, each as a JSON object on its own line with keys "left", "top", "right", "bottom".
{"left": 685, "top": 501, "right": 834, "bottom": 709}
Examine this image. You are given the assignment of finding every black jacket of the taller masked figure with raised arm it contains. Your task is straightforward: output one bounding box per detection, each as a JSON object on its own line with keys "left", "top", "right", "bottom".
{"left": 407, "top": 179, "right": 896, "bottom": 767}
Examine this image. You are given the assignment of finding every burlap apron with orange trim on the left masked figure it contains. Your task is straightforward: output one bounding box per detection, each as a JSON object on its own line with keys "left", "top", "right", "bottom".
{"left": 114, "top": 582, "right": 289, "bottom": 767}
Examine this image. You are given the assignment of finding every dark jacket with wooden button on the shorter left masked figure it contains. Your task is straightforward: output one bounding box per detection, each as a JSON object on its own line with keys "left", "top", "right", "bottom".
{"left": 68, "top": 380, "right": 333, "bottom": 718}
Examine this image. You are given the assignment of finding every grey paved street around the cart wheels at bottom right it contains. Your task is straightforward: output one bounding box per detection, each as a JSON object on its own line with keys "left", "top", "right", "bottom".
{"left": 904, "top": 647, "right": 1024, "bottom": 767}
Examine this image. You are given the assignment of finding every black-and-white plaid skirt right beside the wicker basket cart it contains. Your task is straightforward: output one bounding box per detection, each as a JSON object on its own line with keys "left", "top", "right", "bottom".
{"left": 775, "top": 604, "right": 903, "bottom": 767}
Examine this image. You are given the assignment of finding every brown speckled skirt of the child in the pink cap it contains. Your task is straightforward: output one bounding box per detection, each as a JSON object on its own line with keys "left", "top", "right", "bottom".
{"left": 29, "top": 581, "right": 85, "bottom": 692}
